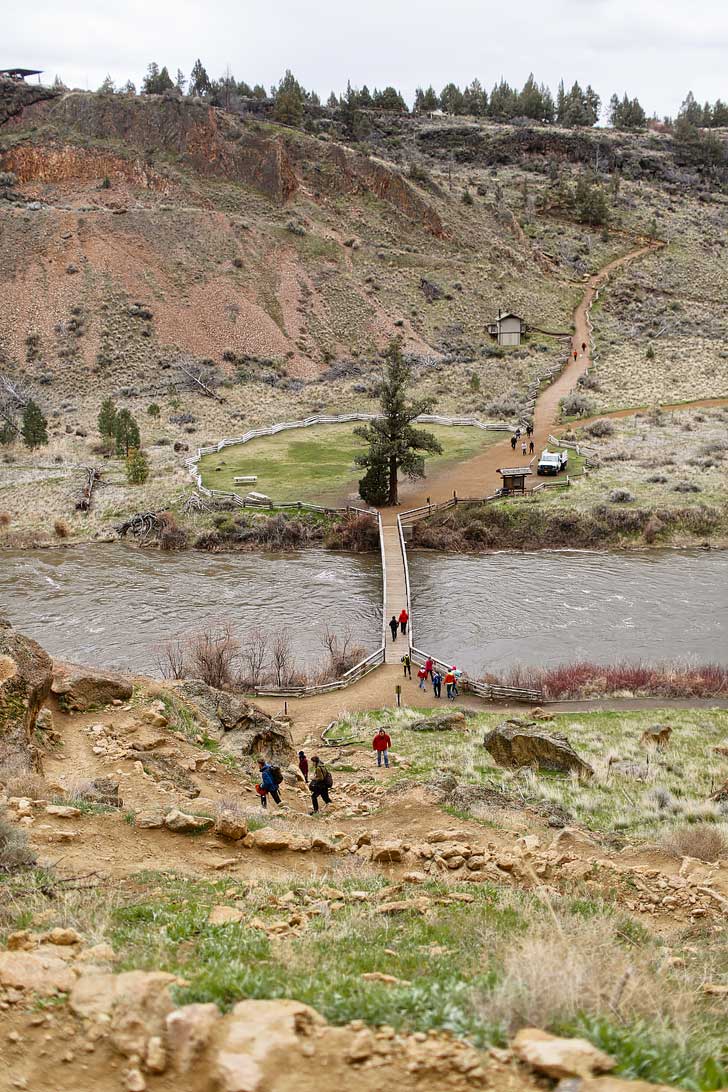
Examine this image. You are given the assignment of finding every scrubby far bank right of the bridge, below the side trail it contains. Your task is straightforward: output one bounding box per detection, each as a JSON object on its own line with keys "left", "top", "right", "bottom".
{"left": 413, "top": 406, "right": 728, "bottom": 551}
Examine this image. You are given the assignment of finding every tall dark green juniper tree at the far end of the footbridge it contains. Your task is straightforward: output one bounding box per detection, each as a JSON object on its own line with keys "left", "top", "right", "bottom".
{"left": 354, "top": 339, "right": 442, "bottom": 505}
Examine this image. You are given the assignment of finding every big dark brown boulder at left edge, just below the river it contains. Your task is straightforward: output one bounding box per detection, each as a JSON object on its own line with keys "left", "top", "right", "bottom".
{"left": 0, "top": 618, "right": 52, "bottom": 772}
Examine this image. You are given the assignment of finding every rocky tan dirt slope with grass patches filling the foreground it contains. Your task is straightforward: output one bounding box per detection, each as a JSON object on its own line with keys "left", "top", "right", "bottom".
{"left": 0, "top": 627, "right": 728, "bottom": 1092}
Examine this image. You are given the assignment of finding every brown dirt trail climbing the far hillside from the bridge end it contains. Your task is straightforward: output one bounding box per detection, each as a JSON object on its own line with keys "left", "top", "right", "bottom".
{"left": 381, "top": 242, "right": 664, "bottom": 525}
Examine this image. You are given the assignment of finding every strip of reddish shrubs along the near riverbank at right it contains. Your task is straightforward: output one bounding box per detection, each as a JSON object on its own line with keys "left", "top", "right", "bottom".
{"left": 484, "top": 661, "right": 728, "bottom": 701}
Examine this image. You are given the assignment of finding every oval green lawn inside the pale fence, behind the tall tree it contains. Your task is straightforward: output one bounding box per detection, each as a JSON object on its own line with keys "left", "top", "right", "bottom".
{"left": 200, "top": 424, "right": 503, "bottom": 503}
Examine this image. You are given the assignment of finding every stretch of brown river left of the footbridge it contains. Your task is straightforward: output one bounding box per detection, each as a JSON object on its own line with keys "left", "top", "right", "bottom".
{"left": 0, "top": 544, "right": 382, "bottom": 675}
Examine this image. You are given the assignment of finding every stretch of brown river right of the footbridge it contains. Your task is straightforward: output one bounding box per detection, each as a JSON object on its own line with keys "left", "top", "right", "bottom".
{"left": 409, "top": 549, "right": 728, "bottom": 674}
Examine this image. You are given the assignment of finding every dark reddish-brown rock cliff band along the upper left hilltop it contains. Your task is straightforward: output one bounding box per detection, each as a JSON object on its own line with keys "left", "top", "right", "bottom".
{"left": 0, "top": 88, "right": 444, "bottom": 236}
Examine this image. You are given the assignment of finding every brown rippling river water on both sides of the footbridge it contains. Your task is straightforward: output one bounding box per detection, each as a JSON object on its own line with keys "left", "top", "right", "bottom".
{"left": 0, "top": 544, "right": 728, "bottom": 675}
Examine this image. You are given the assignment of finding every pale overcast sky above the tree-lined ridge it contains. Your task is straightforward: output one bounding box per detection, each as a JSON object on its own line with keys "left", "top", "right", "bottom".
{"left": 5, "top": 0, "right": 728, "bottom": 116}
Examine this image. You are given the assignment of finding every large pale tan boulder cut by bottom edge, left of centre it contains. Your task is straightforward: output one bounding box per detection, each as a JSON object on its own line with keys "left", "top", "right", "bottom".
{"left": 213, "top": 1000, "right": 324, "bottom": 1092}
